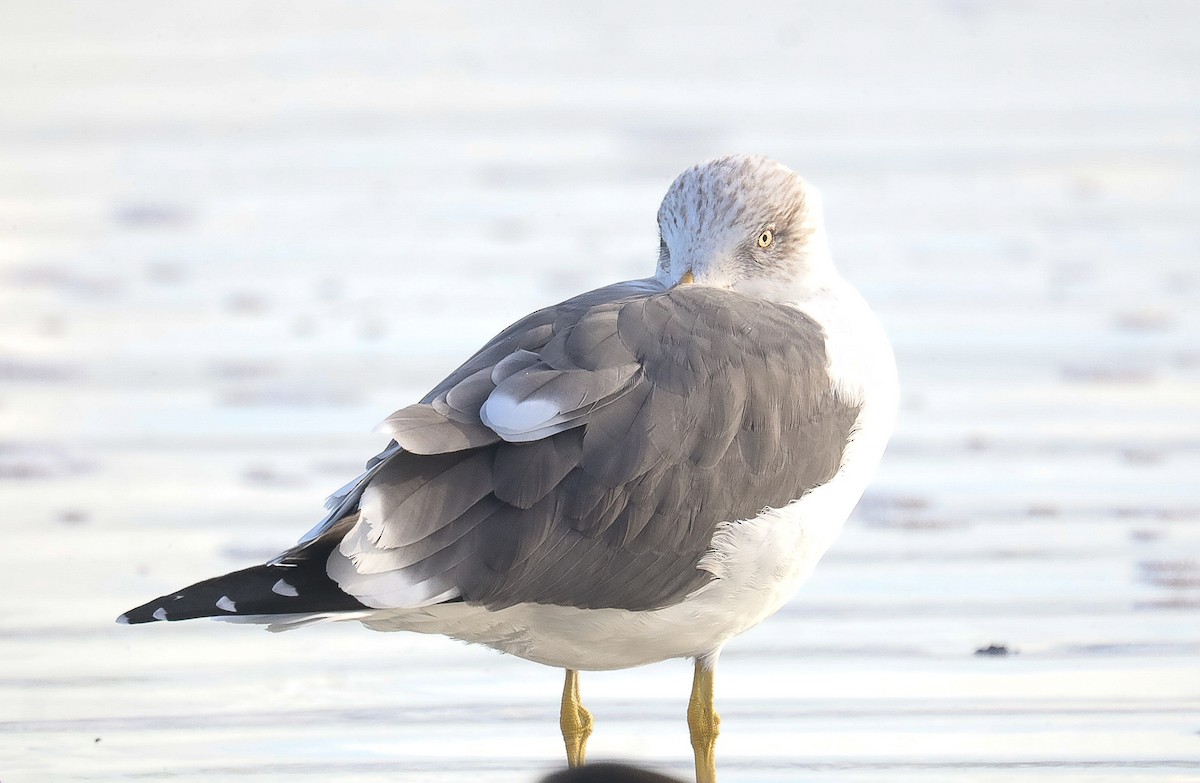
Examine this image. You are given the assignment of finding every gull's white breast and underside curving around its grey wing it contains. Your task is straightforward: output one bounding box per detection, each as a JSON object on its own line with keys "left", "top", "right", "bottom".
{"left": 350, "top": 278, "right": 896, "bottom": 670}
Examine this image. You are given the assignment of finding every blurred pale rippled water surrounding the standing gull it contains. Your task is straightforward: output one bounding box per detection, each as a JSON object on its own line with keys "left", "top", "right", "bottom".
{"left": 0, "top": 0, "right": 1200, "bottom": 783}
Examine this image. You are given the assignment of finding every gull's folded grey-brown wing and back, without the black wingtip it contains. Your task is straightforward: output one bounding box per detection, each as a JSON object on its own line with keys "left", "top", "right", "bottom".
{"left": 328, "top": 282, "right": 858, "bottom": 610}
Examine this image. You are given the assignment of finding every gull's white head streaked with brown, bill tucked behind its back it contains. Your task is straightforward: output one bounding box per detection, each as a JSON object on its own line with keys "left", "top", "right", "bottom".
{"left": 656, "top": 155, "right": 833, "bottom": 301}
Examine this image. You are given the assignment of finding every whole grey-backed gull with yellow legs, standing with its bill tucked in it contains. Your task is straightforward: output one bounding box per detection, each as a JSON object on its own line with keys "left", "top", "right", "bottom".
{"left": 119, "top": 155, "right": 898, "bottom": 783}
